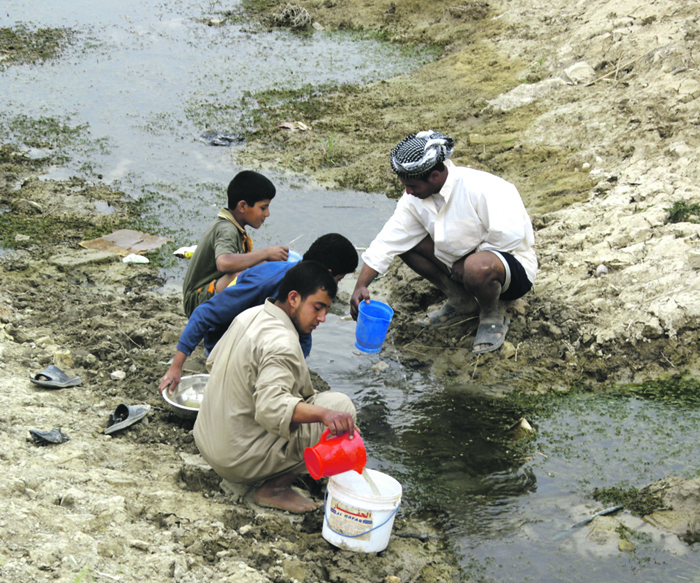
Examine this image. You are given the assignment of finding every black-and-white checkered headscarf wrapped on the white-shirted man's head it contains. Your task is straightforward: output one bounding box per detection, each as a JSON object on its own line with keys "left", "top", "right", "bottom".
{"left": 391, "top": 130, "right": 455, "bottom": 178}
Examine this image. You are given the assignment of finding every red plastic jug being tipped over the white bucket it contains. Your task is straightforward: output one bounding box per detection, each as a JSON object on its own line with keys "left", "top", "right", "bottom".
{"left": 304, "top": 429, "right": 367, "bottom": 480}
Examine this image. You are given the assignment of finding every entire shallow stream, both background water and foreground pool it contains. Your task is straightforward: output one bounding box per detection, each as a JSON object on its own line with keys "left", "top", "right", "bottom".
{"left": 0, "top": 0, "right": 700, "bottom": 583}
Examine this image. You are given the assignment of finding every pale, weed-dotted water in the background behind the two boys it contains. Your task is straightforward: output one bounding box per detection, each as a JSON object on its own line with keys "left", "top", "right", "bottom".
{"left": 0, "top": 0, "right": 434, "bottom": 283}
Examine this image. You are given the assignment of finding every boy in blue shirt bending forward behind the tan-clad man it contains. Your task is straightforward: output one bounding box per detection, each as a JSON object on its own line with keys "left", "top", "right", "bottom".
{"left": 158, "top": 233, "right": 358, "bottom": 393}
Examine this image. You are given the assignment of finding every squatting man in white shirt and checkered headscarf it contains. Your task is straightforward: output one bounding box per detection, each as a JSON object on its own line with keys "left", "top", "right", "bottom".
{"left": 350, "top": 130, "right": 537, "bottom": 354}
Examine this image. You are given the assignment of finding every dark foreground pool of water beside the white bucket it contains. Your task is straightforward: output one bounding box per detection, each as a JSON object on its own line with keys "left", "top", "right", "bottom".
{"left": 309, "top": 315, "right": 700, "bottom": 583}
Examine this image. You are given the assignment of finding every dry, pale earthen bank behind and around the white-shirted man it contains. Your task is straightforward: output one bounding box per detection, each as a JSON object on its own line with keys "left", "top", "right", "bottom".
{"left": 237, "top": 0, "right": 700, "bottom": 390}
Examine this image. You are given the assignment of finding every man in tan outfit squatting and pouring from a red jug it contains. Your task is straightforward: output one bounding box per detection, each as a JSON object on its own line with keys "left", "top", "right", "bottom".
{"left": 194, "top": 261, "right": 357, "bottom": 513}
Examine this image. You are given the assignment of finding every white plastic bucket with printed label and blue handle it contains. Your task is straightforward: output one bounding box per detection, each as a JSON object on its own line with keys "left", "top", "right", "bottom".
{"left": 322, "top": 469, "right": 401, "bottom": 553}
